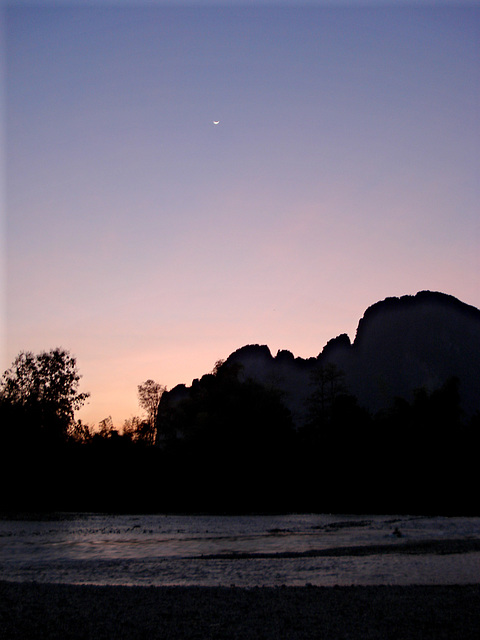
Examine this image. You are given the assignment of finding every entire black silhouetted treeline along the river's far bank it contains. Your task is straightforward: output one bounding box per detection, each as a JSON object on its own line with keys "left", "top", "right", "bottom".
{"left": 0, "top": 350, "right": 480, "bottom": 514}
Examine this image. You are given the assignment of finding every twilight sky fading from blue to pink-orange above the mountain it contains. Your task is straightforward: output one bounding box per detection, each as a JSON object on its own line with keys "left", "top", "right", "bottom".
{"left": 0, "top": 0, "right": 480, "bottom": 427}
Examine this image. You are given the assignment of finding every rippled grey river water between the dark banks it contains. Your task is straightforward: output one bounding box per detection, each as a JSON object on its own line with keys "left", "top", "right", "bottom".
{"left": 0, "top": 513, "right": 480, "bottom": 587}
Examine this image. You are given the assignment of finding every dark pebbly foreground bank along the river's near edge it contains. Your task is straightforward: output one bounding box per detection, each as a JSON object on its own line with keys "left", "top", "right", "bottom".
{"left": 0, "top": 582, "right": 480, "bottom": 640}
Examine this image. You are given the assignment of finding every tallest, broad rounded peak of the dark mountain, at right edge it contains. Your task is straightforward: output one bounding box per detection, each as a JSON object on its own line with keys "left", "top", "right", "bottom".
{"left": 349, "top": 291, "right": 480, "bottom": 413}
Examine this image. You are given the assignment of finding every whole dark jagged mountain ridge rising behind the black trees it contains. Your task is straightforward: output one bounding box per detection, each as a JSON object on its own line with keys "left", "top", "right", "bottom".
{"left": 162, "top": 291, "right": 480, "bottom": 426}
